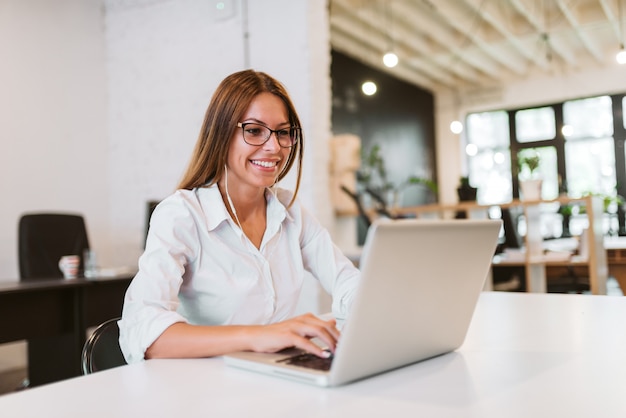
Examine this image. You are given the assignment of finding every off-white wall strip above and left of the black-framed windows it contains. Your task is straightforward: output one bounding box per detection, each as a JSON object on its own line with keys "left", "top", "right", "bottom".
{"left": 435, "top": 63, "right": 626, "bottom": 203}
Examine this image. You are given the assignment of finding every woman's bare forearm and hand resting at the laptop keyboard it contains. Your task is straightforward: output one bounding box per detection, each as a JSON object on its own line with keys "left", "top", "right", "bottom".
{"left": 145, "top": 314, "right": 339, "bottom": 359}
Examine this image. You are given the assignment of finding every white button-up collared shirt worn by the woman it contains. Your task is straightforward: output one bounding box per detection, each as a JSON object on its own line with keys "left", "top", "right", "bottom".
{"left": 119, "top": 186, "right": 360, "bottom": 363}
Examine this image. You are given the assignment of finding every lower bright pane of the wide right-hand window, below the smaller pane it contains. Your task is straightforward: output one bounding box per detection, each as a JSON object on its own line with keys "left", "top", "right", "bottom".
{"left": 565, "top": 138, "right": 617, "bottom": 197}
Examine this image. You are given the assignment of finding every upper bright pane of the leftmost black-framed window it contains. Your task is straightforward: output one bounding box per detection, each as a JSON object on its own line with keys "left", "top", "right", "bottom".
{"left": 466, "top": 110, "right": 509, "bottom": 148}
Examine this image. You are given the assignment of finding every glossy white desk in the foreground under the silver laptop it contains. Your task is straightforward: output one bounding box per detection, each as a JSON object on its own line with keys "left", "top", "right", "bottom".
{"left": 0, "top": 292, "right": 626, "bottom": 418}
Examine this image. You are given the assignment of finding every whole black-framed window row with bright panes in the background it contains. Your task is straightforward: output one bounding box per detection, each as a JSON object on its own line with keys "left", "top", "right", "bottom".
{"left": 466, "top": 94, "right": 626, "bottom": 204}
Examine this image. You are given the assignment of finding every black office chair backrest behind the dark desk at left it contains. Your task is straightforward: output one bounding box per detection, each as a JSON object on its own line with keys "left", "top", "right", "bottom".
{"left": 18, "top": 213, "right": 89, "bottom": 280}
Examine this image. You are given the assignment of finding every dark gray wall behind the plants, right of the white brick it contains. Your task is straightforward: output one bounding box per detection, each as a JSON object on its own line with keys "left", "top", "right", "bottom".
{"left": 331, "top": 51, "right": 437, "bottom": 206}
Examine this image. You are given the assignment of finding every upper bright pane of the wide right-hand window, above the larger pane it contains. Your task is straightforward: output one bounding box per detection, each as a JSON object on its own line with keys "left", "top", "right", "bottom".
{"left": 563, "top": 96, "right": 613, "bottom": 139}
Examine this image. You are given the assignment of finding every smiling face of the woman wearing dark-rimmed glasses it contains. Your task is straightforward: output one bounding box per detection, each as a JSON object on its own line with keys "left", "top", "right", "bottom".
{"left": 227, "top": 93, "right": 291, "bottom": 190}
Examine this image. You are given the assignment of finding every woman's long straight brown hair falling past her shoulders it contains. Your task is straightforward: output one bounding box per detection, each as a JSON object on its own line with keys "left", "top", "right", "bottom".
{"left": 178, "top": 70, "right": 304, "bottom": 205}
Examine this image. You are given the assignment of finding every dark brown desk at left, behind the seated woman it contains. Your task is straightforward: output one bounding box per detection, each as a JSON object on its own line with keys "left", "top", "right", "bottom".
{"left": 0, "top": 276, "right": 132, "bottom": 386}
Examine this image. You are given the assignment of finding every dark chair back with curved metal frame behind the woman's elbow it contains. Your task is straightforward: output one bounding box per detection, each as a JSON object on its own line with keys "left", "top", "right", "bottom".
{"left": 81, "top": 318, "right": 126, "bottom": 374}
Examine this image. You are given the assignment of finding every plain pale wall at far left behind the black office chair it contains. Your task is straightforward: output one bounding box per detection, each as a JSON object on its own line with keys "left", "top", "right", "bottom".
{"left": 0, "top": 0, "right": 109, "bottom": 280}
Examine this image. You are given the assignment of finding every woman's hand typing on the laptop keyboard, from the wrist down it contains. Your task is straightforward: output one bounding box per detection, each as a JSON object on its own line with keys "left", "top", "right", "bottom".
{"left": 250, "top": 313, "right": 340, "bottom": 357}
